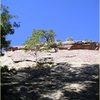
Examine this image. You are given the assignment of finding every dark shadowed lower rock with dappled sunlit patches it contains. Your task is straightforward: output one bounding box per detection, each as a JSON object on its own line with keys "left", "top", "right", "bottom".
{"left": 1, "top": 63, "right": 99, "bottom": 100}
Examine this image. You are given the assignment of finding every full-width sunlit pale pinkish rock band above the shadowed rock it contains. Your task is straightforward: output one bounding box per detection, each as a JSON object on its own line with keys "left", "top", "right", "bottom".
{"left": 0, "top": 49, "right": 100, "bottom": 69}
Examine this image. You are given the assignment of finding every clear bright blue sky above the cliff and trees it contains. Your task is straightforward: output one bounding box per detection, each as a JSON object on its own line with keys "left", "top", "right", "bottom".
{"left": 2, "top": 0, "right": 99, "bottom": 45}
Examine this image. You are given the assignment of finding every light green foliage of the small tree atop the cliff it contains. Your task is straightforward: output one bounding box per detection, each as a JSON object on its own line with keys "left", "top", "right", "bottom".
{"left": 24, "top": 29, "right": 55, "bottom": 48}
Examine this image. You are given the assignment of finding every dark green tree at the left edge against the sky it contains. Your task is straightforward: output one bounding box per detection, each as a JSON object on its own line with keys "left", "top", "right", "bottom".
{"left": 0, "top": 5, "right": 20, "bottom": 54}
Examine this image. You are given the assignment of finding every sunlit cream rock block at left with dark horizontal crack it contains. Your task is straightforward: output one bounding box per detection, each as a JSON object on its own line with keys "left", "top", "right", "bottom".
{"left": 0, "top": 50, "right": 36, "bottom": 69}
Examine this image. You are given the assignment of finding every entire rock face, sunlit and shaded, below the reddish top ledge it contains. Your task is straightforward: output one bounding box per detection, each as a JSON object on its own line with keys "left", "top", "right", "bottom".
{"left": 0, "top": 50, "right": 99, "bottom": 100}
